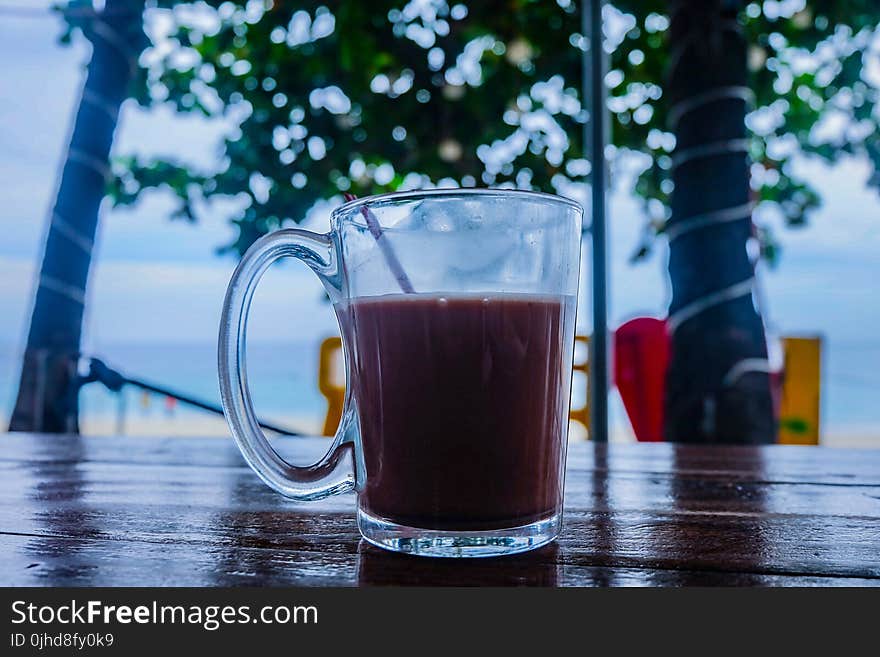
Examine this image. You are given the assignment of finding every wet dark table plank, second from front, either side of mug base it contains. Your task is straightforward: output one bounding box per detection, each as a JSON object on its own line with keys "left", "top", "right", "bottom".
{"left": 0, "top": 503, "right": 880, "bottom": 577}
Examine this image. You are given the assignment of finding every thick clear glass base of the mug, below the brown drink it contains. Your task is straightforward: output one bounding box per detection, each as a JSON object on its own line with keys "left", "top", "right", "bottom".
{"left": 358, "top": 509, "right": 562, "bottom": 558}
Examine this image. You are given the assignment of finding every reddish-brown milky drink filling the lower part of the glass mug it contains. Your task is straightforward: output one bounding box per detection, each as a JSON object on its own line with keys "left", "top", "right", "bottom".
{"left": 338, "top": 294, "right": 575, "bottom": 530}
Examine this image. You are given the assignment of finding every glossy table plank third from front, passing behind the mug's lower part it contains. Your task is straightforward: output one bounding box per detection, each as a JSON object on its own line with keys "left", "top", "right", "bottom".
{"left": 0, "top": 462, "right": 880, "bottom": 516}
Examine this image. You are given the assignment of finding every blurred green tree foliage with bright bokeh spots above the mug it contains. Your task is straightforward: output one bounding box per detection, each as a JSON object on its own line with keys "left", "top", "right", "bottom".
{"left": 70, "top": 0, "right": 880, "bottom": 259}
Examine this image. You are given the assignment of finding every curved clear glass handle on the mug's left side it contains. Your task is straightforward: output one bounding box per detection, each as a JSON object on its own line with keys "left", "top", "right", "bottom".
{"left": 218, "top": 228, "right": 357, "bottom": 500}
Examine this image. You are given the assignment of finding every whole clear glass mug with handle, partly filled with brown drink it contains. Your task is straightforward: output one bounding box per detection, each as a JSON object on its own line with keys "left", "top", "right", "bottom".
{"left": 219, "top": 189, "right": 583, "bottom": 556}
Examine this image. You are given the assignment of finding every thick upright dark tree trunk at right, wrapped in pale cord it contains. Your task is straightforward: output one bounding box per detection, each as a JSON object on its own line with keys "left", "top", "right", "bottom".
{"left": 665, "top": 0, "right": 776, "bottom": 444}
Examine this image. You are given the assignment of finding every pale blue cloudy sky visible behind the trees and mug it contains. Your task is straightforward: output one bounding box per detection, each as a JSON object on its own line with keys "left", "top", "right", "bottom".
{"left": 0, "top": 2, "right": 880, "bottom": 438}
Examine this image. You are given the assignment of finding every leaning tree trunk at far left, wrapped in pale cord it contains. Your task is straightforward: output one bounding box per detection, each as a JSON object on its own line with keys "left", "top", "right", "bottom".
{"left": 9, "top": 0, "right": 144, "bottom": 433}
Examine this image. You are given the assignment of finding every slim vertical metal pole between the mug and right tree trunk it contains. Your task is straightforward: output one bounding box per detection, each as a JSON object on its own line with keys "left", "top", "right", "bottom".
{"left": 581, "top": 0, "right": 608, "bottom": 443}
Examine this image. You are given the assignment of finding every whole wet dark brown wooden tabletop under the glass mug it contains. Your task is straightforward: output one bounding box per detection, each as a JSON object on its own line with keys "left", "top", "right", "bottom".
{"left": 0, "top": 434, "right": 880, "bottom": 586}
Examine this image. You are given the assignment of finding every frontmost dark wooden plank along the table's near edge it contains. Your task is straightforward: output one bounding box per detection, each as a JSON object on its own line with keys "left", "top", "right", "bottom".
{"left": 0, "top": 534, "right": 880, "bottom": 587}
